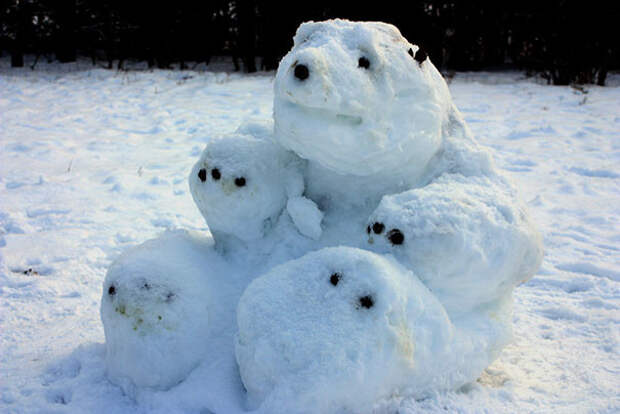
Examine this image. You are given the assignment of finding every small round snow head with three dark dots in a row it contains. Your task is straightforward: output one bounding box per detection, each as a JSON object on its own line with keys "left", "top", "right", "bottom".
{"left": 189, "top": 133, "right": 303, "bottom": 241}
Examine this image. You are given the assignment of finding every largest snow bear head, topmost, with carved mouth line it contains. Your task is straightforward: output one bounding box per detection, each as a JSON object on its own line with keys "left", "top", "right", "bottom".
{"left": 274, "top": 20, "right": 451, "bottom": 176}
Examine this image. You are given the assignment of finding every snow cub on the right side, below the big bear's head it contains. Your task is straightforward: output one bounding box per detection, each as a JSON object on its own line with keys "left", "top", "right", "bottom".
{"left": 366, "top": 174, "right": 542, "bottom": 315}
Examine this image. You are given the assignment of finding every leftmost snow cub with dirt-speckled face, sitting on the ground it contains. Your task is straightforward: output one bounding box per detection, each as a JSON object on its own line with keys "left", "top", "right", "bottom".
{"left": 101, "top": 230, "right": 227, "bottom": 395}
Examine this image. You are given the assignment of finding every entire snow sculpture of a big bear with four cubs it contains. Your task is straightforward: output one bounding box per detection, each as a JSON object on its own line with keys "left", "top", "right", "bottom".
{"left": 101, "top": 20, "right": 542, "bottom": 412}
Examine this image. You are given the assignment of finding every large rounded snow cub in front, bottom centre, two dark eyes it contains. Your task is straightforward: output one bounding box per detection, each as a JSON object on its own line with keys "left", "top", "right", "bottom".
{"left": 236, "top": 247, "right": 450, "bottom": 412}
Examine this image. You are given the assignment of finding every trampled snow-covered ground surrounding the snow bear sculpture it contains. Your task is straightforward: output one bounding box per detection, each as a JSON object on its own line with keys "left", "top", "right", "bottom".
{"left": 0, "top": 59, "right": 620, "bottom": 413}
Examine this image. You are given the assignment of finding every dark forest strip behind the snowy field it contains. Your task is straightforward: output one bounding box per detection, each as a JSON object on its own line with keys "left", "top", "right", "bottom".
{"left": 0, "top": 0, "right": 620, "bottom": 85}
